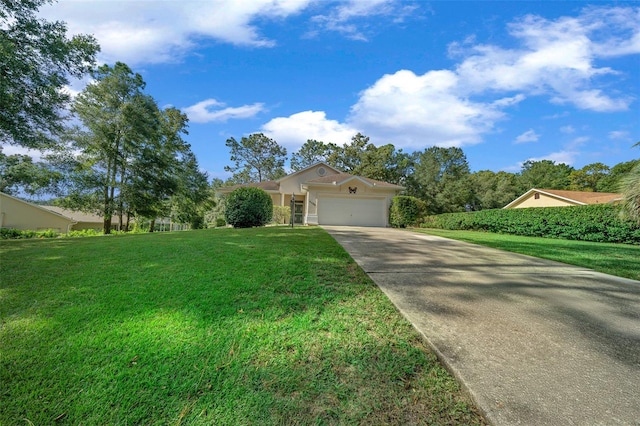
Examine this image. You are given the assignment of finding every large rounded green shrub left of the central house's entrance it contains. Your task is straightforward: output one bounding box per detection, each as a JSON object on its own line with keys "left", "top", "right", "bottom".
{"left": 225, "top": 187, "right": 273, "bottom": 228}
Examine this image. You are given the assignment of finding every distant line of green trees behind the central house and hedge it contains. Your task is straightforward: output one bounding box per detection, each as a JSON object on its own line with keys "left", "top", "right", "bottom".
{"left": 226, "top": 133, "right": 640, "bottom": 218}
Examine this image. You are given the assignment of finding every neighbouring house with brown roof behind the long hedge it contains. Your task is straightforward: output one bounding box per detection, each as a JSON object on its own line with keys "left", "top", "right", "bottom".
{"left": 503, "top": 188, "right": 622, "bottom": 209}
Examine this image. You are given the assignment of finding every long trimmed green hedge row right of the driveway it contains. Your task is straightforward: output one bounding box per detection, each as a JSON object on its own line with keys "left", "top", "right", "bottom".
{"left": 421, "top": 204, "right": 640, "bottom": 244}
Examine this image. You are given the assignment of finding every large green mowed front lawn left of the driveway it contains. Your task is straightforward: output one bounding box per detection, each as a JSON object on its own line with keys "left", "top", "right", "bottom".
{"left": 0, "top": 227, "right": 484, "bottom": 425}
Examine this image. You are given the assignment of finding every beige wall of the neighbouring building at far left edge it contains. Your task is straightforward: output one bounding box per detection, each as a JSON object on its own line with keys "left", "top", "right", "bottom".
{"left": 0, "top": 194, "right": 73, "bottom": 233}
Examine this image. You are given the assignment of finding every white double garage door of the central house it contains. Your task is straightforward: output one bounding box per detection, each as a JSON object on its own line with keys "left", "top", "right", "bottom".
{"left": 318, "top": 197, "right": 387, "bottom": 226}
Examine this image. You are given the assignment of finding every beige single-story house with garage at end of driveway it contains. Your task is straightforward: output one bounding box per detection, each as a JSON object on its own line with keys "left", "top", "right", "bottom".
{"left": 218, "top": 163, "right": 404, "bottom": 227}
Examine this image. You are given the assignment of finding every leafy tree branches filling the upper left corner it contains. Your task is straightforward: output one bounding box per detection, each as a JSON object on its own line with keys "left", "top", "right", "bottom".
{"left": 0, "top": 0, "right": 99, "bottom": 149}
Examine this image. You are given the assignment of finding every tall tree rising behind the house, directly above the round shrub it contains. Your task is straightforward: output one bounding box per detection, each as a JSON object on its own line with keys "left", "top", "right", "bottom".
{"left": 224, "top": 133, "right": 287, "bottom": 183}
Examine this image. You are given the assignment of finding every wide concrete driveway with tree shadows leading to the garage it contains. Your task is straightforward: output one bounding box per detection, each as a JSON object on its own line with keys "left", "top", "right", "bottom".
{"left": 324, "top": 227, "right": 640, "bottom": 426}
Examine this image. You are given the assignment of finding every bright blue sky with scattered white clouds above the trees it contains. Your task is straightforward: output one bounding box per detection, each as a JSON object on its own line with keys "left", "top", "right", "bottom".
{"left": 32, "top": 0, "right": 640, "bottom": 179}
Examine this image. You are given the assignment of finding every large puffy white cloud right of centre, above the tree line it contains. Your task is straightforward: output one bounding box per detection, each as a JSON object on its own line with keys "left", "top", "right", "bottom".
{"left": 348, "top": 70, "right": 514, "bottom": 148}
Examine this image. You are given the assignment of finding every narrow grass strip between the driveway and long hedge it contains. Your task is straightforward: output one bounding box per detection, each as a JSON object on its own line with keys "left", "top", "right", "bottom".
{"left": 414, "top": 229, "right": 640, "bottom": 280}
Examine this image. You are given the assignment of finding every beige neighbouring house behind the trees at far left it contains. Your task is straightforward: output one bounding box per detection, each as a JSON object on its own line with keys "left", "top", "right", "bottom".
{"left": 0, "top": 192, "right": 118, "bottom": 234}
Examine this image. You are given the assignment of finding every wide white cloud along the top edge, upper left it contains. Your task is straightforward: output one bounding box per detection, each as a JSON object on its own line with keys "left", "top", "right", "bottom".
{"left": 41, "top": 0, "right": 312, "bottom": 65}
